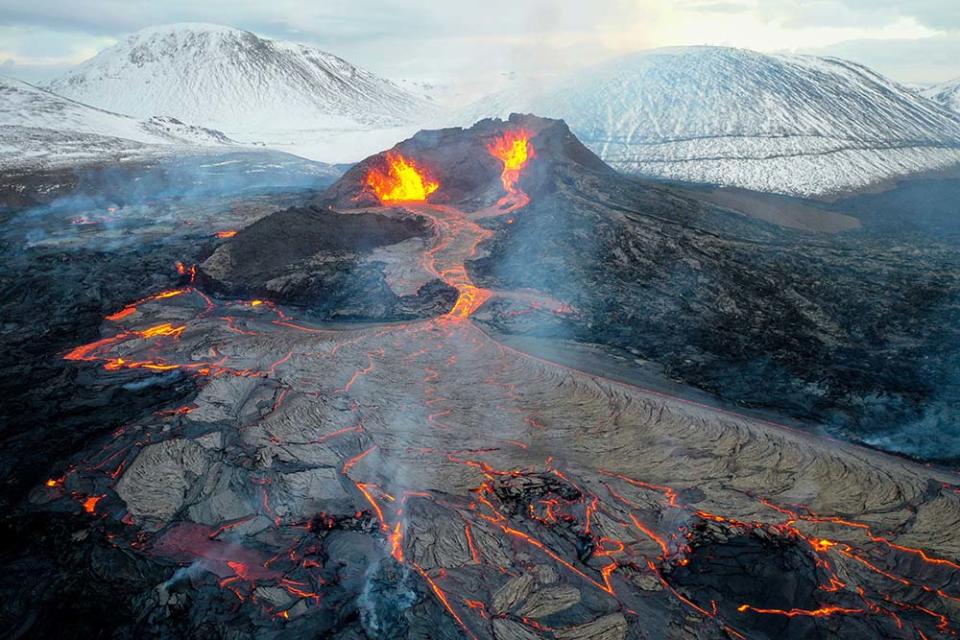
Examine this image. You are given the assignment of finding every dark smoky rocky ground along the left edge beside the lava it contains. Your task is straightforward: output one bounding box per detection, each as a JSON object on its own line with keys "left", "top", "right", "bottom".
{"left": 0, "top": 154, "right": 344, "bottom": 637}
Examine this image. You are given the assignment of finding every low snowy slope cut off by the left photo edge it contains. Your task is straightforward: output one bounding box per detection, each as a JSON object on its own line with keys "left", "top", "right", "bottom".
{"left": 0, "top": 76, "right": 231, "bottom": 167}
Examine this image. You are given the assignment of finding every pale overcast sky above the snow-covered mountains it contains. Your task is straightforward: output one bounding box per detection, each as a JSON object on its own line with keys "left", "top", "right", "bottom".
{"left": 0, "top": 0, "right": 960, "bottom": 83}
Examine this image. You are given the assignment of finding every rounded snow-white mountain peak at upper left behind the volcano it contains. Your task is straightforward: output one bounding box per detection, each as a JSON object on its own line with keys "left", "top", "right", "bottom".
{"left": 47, "top": 24, "right": 434, "bottom": 161}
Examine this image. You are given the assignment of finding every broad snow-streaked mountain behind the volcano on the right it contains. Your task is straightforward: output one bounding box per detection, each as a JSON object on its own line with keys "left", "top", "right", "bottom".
{"left": 455, "top": 47, "right": 960, "bottom": 196}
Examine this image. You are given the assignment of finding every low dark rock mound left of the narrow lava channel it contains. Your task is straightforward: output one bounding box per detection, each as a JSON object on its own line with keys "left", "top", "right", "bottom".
{"left": 198, "top": 207, "right": 456, "bottom": 320}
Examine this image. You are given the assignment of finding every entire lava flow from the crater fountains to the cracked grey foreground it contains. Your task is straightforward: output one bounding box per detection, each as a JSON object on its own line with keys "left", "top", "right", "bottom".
{"left": 38, "top": 127, "right": 960, "bottom": 640}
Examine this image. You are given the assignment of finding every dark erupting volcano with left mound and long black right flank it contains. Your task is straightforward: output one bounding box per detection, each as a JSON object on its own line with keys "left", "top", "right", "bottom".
{"left": 201, "top": 115, "right": 960, "bottom": 457}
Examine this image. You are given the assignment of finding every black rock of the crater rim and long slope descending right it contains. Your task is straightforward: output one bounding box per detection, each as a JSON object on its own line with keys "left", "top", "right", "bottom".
{"left": 323, "top": 114, "right": 960, "bottom": 459}
